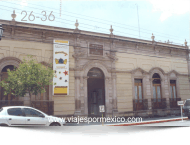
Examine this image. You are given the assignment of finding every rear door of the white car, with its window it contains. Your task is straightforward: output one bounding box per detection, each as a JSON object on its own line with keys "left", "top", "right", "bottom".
{"left": 5, "top": 107, "right": 25, "bottom": 126}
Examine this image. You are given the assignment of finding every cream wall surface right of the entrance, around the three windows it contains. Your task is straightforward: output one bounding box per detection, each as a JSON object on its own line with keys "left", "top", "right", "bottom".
{"left": 115, "top": 53, "right": 190, "bottom": 112}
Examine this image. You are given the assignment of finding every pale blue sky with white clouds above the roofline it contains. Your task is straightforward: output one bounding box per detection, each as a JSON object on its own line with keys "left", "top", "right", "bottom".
{"left": 0, "top": 0, "right": 190, "bottom": 45}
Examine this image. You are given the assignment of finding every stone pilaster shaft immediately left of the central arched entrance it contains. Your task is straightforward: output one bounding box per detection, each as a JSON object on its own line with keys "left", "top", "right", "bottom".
{"left": 74, "top": 76, "right": 81, "bottom": 115}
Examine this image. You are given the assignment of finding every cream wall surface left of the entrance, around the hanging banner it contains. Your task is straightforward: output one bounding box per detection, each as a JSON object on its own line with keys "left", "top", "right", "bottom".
{"left": 0, "top": 39, "right": 75, "bottom": 115}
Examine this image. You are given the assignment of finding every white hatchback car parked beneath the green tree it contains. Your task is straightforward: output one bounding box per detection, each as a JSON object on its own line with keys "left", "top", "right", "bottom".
{"left": 0, "top": 106, "right": 66, "bottom": 126}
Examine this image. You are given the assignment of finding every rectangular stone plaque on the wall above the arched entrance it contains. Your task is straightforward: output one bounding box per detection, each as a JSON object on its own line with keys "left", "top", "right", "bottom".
{"left": 89, "top": 44, "right": 103, "bottom": 55}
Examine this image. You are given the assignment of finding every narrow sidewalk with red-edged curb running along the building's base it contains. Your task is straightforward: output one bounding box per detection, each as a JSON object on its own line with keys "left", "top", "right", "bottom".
{"left": 66, "top": 116, "right": 188, "bottom": 126}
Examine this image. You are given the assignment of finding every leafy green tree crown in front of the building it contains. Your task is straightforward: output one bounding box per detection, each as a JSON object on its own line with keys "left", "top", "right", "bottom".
{"left": 0, "top": 55, "right": 54, "bottom": 106}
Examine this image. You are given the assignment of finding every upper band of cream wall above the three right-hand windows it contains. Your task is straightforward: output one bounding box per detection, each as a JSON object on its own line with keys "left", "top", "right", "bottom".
{"left": 116, "top": 53, "right": 188, "bottom": 74}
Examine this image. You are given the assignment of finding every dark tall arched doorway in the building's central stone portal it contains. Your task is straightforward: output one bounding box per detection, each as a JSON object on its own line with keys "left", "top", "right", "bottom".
{"left": 87, "top": 68, "right": 106, "bottom": 117}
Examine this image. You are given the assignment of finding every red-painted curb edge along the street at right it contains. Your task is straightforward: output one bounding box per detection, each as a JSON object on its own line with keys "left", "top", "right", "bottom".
{"left": 107, "top": 117, "right": 188, "bottom": 126}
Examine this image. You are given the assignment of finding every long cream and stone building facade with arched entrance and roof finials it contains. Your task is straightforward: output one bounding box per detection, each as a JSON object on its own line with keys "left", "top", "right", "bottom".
{"left": 0, "top": 20, "right": 190, "bottom": 116}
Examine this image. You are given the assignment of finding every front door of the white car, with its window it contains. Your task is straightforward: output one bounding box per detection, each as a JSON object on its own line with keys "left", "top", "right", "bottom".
{"left": 23, "top": 108, "right": 47, "bottom": 126}
